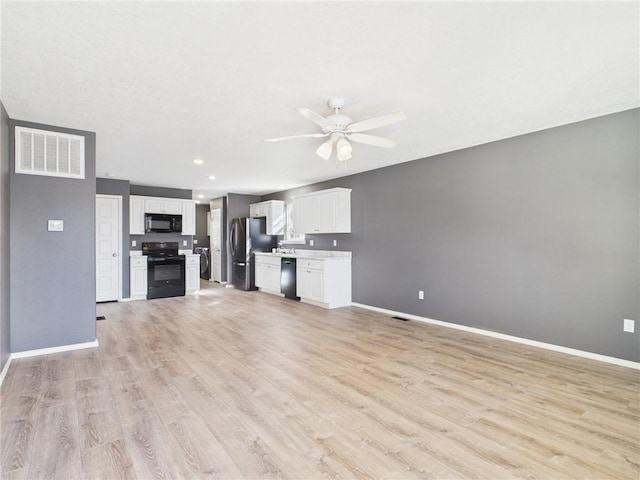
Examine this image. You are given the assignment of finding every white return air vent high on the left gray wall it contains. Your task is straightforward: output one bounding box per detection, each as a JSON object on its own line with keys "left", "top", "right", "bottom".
{"left": 16, "top": 127, "right": 84, "bottom": 178}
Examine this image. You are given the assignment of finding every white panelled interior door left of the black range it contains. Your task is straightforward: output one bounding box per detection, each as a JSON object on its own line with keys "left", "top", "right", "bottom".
{"left": 96, "top": 195, "right": 122, "bottom": 302}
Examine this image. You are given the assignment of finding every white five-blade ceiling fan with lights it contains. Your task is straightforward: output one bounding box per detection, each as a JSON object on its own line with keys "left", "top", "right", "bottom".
{"left": 265, "top": 97, "right": 407, "bottom": 162}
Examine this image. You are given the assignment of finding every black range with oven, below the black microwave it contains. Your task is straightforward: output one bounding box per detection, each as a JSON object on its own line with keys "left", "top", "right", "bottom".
{"left": 142, "top": 242, "right": 185, "bottom": 298}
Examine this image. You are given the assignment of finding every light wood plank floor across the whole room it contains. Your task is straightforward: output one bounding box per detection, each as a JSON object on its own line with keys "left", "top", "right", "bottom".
{"left": 1, "top": 282, "right": 640, "bottom": 480}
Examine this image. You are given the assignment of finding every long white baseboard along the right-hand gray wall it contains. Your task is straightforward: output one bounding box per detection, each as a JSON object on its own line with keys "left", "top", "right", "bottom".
{"left": 351, "top": 302, "right": 640, "bottom": 370}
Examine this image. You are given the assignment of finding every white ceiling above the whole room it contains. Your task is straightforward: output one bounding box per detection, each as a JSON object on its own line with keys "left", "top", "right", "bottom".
{"left": 1, "top": 1, "right": 640, "bottom": 198}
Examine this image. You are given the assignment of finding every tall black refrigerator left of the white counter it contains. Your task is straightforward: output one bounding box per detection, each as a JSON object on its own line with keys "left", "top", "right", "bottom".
{"left": 229, "top": 218, "right": 277, "bottom": 290}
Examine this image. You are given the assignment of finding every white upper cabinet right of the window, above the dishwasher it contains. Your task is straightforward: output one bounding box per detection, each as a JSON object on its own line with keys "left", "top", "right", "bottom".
{"left": 293, "top": 188, "right": 351, "bottom": 233}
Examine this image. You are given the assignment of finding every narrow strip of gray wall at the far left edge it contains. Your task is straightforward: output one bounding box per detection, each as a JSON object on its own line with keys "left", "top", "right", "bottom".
{"left": 0, "top": 102, "right": 11, "bottom": 371}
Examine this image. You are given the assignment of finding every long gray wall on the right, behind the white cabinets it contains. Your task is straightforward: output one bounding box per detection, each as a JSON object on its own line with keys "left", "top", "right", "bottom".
{"left": 263, "top": 109, "right": 640, "bottom": 362}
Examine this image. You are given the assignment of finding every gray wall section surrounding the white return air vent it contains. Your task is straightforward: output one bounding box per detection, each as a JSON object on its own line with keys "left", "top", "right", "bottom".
{"left": 9, "top": 120, "right": 96, "bottom": 352}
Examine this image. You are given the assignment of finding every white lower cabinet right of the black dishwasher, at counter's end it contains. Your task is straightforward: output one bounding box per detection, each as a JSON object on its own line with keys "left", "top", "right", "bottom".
{"left": 296, "top": 258, "right": 351, "bottom": 308}
